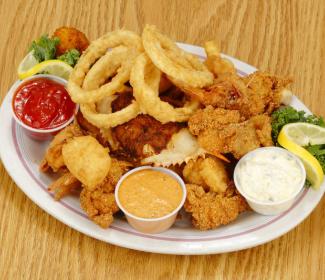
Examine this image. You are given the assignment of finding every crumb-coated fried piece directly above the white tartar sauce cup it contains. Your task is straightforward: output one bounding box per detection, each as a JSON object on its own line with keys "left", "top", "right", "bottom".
{"left": 188, "top": 106, "right": 273, "bottom": 159}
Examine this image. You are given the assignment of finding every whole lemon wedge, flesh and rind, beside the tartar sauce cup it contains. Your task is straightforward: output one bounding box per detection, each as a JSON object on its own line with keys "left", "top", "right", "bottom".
{"left": 278, "top": 123, "right": 325, "bottom": 189}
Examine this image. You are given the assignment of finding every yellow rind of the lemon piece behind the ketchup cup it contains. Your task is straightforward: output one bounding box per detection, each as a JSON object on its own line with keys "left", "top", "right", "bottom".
{"left": 18, "top": 59, "right": 73, "bottom": 80}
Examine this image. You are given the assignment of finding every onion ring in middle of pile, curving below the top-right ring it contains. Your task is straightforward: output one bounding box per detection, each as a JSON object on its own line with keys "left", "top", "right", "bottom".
{"left": 130, "top": 53, "right": 198, "bottom": 123}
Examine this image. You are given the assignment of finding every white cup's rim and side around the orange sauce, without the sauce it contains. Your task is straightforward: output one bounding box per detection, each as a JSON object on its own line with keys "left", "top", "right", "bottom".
{"left": 115, "top": 166, "right": 186, "bottom": 233}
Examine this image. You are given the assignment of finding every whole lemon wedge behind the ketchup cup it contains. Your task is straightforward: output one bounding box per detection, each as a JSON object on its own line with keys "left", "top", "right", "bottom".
{"left": 18, "top": 55, "right": 73, "bottom": 80}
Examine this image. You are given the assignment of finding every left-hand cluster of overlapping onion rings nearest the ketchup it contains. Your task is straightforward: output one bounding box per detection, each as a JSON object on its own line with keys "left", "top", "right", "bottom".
{"left": 68, "top": 30, "right": 143, "bottom": 128}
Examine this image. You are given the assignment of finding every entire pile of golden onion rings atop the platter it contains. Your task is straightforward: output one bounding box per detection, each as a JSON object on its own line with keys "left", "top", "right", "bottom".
{"left": 68, "top": 26, "right": 213, "bottom": 129}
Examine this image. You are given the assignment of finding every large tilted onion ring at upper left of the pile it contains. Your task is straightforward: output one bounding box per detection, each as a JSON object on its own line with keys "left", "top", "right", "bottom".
{"left": 68, "top": 30, "right": 143, "bottom": 103}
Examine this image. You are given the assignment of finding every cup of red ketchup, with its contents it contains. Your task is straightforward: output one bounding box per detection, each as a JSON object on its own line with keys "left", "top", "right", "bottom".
{"left": 9, "top": 74, "right": 78, "bottom": 141}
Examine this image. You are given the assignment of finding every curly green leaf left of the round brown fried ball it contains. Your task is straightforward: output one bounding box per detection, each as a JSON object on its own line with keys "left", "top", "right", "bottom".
{"left": 29, "top": 35, "right": 60, "bottom": 62}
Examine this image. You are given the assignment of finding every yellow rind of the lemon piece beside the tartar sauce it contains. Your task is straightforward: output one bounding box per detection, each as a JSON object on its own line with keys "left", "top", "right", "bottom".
{"left": 278, "top": 123, "right": 324, "bottom": 189}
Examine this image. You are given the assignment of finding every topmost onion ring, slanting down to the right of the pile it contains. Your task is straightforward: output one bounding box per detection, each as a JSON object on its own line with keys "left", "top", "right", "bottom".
{"left": 142, "top": 25, "right": 213, "bottom": 88}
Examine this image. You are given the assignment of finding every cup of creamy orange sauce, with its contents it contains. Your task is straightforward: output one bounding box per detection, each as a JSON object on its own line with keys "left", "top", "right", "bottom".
{"left": 115, "top": 166, "right": 186, "bottom": 233}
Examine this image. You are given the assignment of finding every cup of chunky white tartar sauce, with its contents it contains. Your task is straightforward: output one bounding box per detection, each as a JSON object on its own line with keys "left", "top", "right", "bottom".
{"left": 234, "top": 147, "right": 306, "bottom": 215}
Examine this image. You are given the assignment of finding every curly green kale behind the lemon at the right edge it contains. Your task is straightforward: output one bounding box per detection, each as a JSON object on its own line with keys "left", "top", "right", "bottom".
{"left": 272, "top": 106, "right": 325, "bottom": 143}
